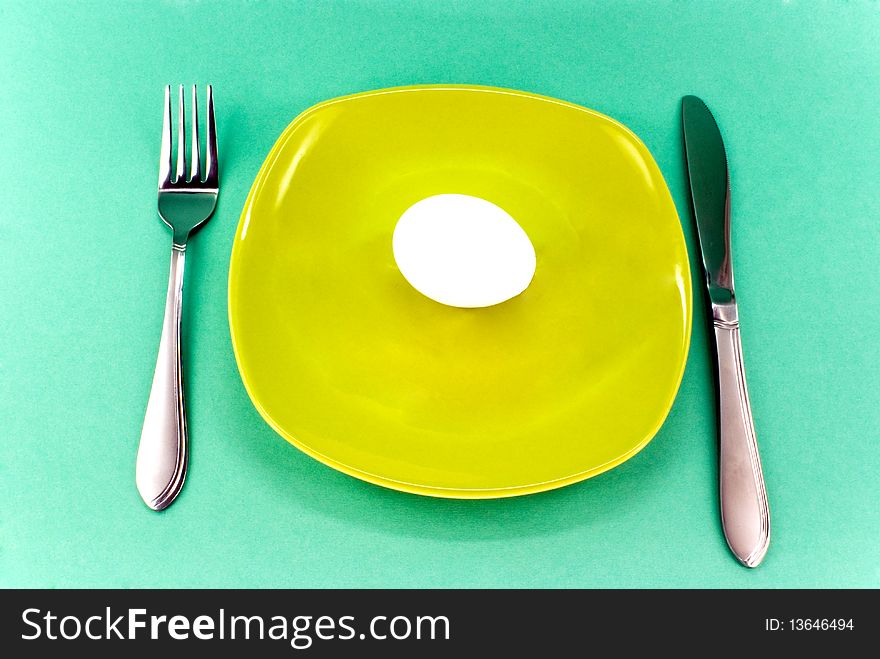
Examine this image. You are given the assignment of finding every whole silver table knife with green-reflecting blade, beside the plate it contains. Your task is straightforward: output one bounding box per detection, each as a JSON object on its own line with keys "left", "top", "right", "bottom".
{"left": 681, "top": 96, "right": 770, "bottom": 567}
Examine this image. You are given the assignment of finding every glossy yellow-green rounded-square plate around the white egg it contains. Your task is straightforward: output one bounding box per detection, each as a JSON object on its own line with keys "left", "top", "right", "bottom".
{"left": 229, "top": 86, "right": 691, "bottom": 498}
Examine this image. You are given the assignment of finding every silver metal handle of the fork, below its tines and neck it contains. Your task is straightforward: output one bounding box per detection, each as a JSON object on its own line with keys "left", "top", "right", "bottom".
{"left": 136, "top": 243, "right": 187, "bottom": 510}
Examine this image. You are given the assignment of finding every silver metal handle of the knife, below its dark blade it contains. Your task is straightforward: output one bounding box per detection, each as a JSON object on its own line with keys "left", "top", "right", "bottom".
{"left": 713, "top": 303, "right": 770, "bottom": 567}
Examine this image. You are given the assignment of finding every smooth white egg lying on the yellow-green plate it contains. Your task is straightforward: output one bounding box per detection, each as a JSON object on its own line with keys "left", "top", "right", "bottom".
{"left": 392, "top": 194, "right": 536, "bottom": 308}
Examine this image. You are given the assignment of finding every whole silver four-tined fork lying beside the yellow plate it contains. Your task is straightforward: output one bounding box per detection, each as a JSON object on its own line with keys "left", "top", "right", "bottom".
{"left": 136, "top": 85, "right": 219, "bottom": 510}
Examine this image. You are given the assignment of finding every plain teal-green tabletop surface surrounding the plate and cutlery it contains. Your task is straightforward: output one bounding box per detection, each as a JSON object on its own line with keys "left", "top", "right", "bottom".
{"left": 0, "top": 0, "right": 880, "bottom": 587}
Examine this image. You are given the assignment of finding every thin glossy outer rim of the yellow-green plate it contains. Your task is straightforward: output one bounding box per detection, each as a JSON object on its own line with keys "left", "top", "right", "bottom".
{"left": 226, "top": 83, "right": 694, "bottom": 499}
